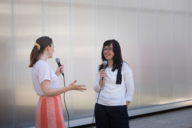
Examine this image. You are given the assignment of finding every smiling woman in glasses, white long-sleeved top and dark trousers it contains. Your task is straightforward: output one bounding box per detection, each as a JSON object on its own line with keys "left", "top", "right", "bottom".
{"left": 94, "top": 40, "right": 134, "bottom": 128}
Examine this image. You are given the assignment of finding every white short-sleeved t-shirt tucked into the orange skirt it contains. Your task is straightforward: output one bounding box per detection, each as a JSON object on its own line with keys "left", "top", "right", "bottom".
{"left": 31, "top": 60, "right": 59, "bottom": 96}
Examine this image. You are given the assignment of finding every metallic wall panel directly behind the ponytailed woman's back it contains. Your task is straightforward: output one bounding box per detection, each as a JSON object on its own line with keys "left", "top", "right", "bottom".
{"left": 14, "top": 0, "right": 42, "bottom": 127}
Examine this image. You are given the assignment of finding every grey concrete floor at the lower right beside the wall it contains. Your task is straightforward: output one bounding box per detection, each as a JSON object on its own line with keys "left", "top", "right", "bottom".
{"left": 89, "top": 107, "right": 192, "bottom": 128}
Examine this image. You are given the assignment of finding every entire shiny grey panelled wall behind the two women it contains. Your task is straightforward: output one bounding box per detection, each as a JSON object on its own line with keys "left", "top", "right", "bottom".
{"left": 0, "top": 0, "right": 192, "bottom": 127}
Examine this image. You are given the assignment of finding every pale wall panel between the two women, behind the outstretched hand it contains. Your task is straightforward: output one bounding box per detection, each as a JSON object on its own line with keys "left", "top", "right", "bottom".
{"left": 71, "top": 0, "right": 96, "bottom": 119}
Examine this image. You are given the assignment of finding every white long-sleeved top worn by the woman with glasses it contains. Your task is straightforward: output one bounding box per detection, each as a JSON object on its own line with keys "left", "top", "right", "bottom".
{"left": 93, "top": 62, "right": 134, "bottom": 106}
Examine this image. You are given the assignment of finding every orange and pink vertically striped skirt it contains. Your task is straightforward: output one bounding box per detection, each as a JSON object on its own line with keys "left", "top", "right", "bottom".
{"left": 36, "top": 95, "right": 65, "bottom": 128}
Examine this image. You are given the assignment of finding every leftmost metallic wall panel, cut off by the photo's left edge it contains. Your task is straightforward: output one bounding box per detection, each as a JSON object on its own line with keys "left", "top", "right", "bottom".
{"left": 0, "top": 0, "right": 14, "bottom": 128}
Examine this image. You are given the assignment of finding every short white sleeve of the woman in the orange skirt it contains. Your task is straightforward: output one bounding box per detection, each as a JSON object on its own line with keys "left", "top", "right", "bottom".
{"left": 38, "top": 64, "right": 51, "bottom": 84}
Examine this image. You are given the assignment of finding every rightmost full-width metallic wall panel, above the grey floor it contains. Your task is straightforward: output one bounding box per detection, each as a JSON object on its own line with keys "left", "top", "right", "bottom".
{"left": 173, "top": 0, "right": 190, "bottom": 101}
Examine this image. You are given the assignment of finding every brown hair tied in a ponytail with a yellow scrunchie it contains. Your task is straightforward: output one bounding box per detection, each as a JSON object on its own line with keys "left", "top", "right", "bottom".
{"left": 29, "top": 36, "right": 52, "bottom": 67}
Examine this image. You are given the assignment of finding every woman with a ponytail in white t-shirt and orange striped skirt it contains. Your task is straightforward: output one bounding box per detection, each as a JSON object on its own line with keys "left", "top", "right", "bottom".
{"left": 29, "top": 36, "right": 86, "bottom": 128}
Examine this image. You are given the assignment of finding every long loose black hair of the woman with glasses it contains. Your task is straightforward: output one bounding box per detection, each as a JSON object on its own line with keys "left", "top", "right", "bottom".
{"left": 99, "top": 39, "right": 123, "bottom": 71}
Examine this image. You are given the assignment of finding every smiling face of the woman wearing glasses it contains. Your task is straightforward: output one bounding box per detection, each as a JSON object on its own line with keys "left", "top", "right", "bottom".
{"left": 103, "top": 43, "right": 115, "bottom": 60}
